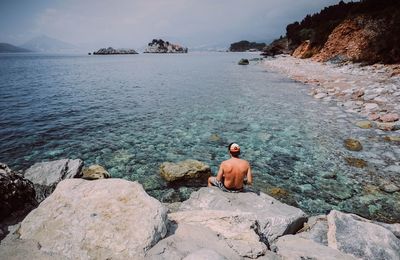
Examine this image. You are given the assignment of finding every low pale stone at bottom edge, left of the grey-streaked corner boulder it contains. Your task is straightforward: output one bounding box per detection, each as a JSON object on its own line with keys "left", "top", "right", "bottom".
{"left": 276, "top": 235, "right": 357, "bottom": 260}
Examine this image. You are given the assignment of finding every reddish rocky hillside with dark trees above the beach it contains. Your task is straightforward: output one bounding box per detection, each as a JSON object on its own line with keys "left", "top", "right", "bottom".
{"left": 266, "top": 0, "right": 400, "bottom": 64}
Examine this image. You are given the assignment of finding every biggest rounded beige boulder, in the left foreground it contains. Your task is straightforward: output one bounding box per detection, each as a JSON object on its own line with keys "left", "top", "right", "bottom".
{"left": 19, "top": 179, "right": 166, "bottom": 259}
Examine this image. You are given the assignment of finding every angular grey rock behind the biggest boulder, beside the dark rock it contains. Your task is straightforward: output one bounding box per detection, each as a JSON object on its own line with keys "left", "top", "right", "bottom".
{"left": 24, "top": 159, "right": 83, "bottom": 202}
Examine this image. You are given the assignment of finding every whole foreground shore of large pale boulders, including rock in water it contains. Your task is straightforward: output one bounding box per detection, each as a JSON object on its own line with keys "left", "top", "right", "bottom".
{"left": 0, "top": 159, "right": 400, "bottom": 259}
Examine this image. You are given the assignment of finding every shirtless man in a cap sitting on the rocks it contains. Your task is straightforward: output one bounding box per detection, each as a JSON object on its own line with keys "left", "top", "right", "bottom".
{"left": 208, "top": 143, "right": 253, "bottom": 192}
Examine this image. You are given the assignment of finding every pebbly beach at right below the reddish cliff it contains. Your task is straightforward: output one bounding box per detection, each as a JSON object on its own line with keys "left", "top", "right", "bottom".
{"left": 264, "top": 55, "right": 400, "bottom": 131}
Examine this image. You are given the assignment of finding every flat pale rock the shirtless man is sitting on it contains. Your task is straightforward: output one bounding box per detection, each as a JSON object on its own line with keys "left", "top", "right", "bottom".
{"left": 180, "top": 188, "right": 306, "bottom": 244}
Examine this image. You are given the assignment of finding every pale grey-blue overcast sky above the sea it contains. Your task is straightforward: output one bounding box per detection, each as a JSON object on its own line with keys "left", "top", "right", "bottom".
{"left": 0, "top": 0, "right": 350, "bottom": 49}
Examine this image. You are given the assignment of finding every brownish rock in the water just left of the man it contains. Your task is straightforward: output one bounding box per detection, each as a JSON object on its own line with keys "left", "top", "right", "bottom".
{"left": 160, "top": 160, "right": 211, "bottom": 185}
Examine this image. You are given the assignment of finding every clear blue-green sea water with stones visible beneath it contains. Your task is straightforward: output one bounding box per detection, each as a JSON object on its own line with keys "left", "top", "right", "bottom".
{"left": 0, "top": 53, "right": 400, "bottom": 222}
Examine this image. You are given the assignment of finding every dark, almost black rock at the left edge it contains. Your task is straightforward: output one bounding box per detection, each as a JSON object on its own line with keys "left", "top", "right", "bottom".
{"left": 0, "top": 163, "right": 38, "bottom": 240}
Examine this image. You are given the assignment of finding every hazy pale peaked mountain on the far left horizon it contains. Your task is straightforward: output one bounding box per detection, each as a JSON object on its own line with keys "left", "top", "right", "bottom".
{"left": 20, "top": 35, "right": 78, "bottom": 52}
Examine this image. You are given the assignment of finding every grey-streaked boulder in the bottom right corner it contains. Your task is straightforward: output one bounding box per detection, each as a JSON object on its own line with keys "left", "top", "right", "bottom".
{"left": 328, "top": 210, "right": 400, "bottom": 260}
